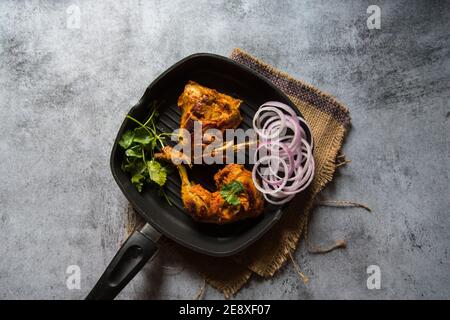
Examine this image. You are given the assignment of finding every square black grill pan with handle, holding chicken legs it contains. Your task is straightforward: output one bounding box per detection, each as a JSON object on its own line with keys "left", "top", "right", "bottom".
{"left": 87, "top": 53, "right": 311, "bottom": 299}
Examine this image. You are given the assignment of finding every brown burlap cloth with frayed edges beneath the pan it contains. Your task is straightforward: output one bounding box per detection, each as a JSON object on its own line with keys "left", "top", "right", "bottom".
{"left": 126, "top": 49, "right": 350, "bottom": 298}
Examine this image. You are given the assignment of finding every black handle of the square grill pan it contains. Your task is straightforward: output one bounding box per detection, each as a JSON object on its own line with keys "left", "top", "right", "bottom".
{"left": 86, "top": 224, "right": 161, "bottom": 300}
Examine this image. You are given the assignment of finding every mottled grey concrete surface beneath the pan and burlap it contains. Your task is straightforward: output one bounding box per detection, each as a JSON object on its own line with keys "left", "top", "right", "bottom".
{"left": 0, "top": 0, "right": 450, "bottom": 299}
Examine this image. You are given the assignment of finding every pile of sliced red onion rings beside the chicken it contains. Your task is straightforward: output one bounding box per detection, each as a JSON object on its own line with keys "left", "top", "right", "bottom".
{"left": 252, "top": 101, "right": 315, "bottom": 205}
